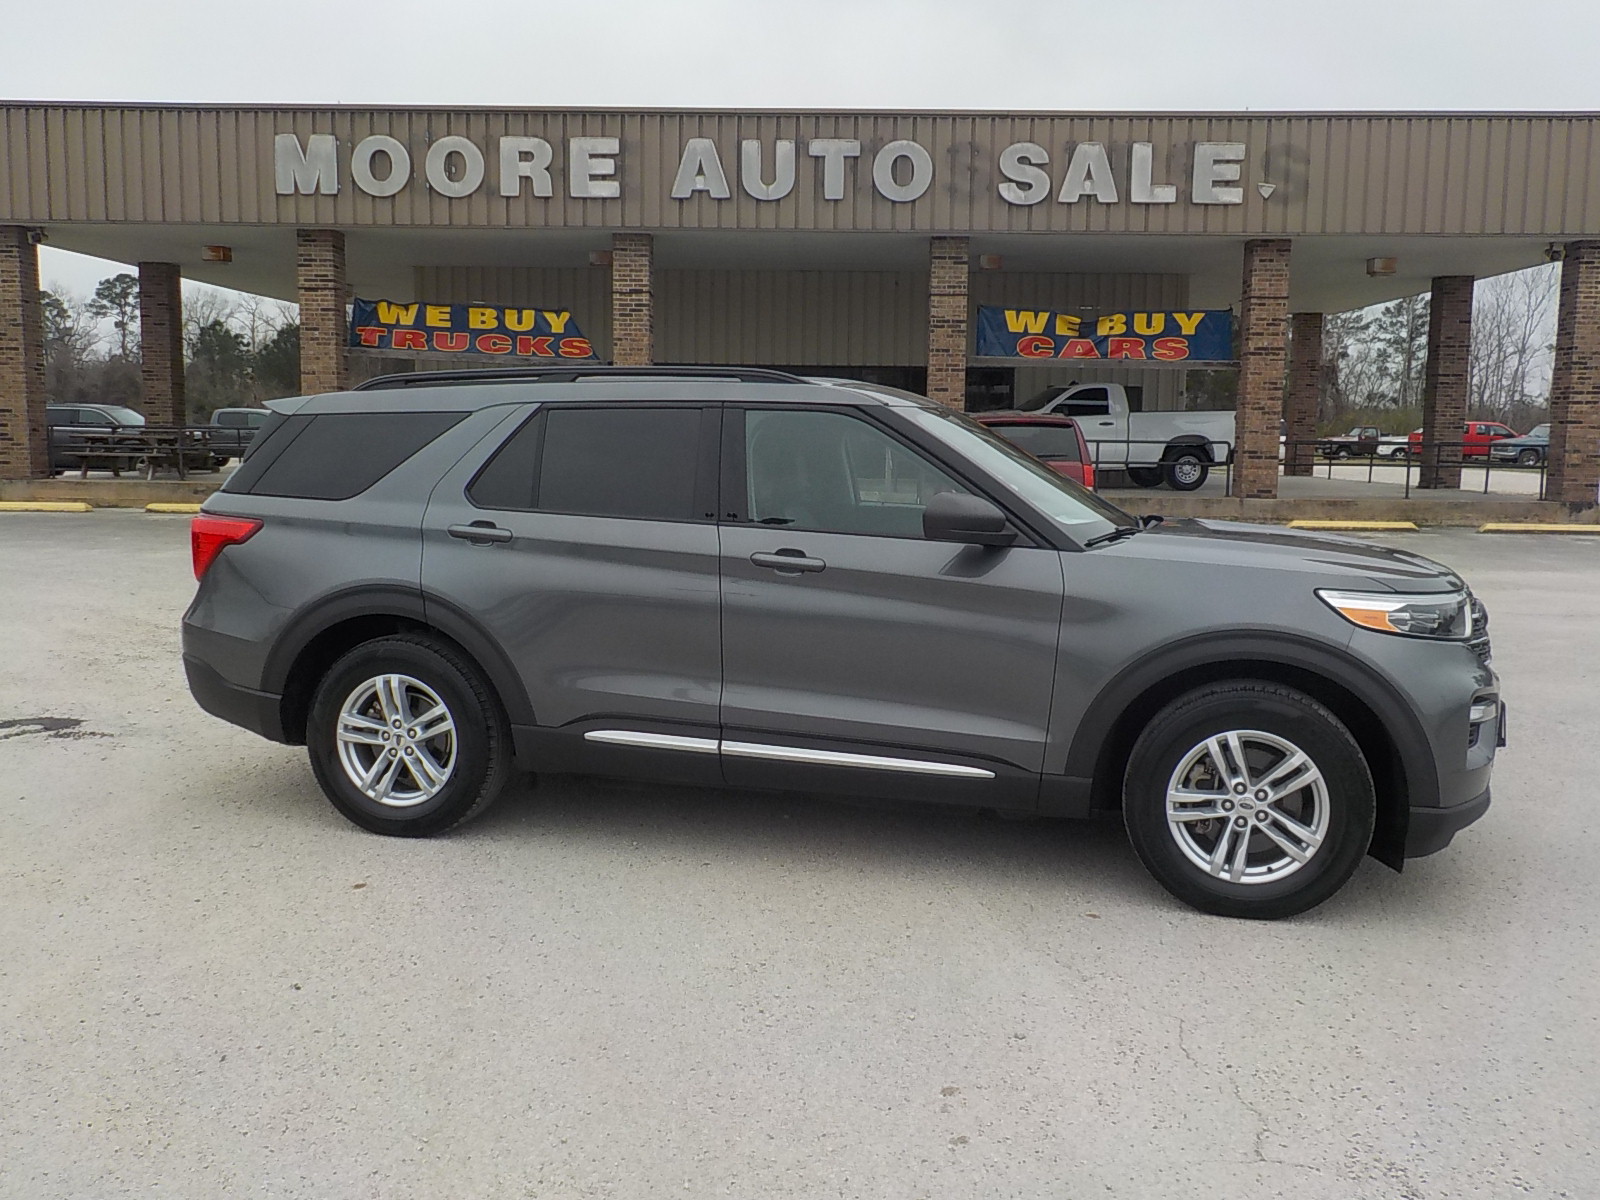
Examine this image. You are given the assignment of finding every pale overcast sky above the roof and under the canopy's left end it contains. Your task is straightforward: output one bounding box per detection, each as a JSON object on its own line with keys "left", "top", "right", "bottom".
{"left": 25, "top": 0, "right": 1600, "bottom": 299}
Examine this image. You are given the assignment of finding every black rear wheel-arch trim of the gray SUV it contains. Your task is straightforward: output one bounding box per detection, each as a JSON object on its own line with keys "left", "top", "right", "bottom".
{"left": 262, "top": 584, "right": 534, "bottom": 725}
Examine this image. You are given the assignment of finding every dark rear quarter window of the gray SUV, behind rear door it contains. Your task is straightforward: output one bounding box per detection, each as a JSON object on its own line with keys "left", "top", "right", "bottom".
{"left": 248, "top": 413, "right": 466, "bottom": 499}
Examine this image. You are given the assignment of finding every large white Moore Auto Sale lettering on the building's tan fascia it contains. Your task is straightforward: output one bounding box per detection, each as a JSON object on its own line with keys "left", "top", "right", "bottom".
{"left": 272, "top": 133, "right": 1270, "bottom": 206}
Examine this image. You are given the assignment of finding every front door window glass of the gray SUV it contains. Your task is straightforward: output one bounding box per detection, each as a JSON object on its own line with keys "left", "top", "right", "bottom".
{"left": 744, "top": 410, "right": 966, "bottom": 538}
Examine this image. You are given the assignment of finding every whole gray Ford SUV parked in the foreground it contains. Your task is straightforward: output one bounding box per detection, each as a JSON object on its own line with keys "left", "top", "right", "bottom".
{"left": 182, "top": 368, "right": 1504, "bottom": 917}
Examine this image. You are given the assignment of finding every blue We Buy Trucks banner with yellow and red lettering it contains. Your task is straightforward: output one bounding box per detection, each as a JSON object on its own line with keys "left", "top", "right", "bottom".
{"left": 350, "top": 299, "right": 595, "bottom": 358}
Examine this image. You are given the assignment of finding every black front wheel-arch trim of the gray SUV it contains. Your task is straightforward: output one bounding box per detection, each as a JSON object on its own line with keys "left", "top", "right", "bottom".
{"left": 1064, "top": 630, "right": 1438, "bottom": 806}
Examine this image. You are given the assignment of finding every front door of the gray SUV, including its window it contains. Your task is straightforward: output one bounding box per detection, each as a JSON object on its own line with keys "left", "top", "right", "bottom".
{"left": 720, "top": 405, "right": 1062, "bottom": 803}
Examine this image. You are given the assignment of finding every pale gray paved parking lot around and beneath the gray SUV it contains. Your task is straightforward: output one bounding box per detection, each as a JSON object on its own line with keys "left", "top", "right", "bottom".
{"left": 0, "top": 512, "right": 1600, "bottom": 1200}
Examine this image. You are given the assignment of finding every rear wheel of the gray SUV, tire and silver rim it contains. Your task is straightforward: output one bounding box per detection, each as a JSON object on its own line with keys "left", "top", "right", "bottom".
{"left": 306, "top": 635, "right": 512, "bottom": 837}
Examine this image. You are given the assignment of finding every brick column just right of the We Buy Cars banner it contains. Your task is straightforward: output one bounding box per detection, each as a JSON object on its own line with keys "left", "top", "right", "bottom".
{"left": 1234, "top": 238, "right": 1290, "bottom": 499}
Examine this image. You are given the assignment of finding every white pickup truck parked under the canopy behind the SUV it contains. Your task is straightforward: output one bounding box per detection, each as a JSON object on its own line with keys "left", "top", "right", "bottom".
{"left": 1018, "top": 384, "right": 1234, "bottom": 491}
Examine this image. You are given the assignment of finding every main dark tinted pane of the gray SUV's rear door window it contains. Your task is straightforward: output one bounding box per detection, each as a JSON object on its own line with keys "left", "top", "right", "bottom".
{"left": 534, "top": 406, "right": 701, "bottom": 522}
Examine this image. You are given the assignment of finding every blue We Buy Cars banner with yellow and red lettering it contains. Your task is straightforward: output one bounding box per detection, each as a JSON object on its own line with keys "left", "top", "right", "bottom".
{"left": 978, "top": 304, "right": 1234, "bottom": 363}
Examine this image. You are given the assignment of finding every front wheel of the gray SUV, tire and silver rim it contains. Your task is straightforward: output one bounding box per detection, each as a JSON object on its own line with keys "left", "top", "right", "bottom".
{"left": 1123, "top": 680, "right": 1378, "bottom": 920}
